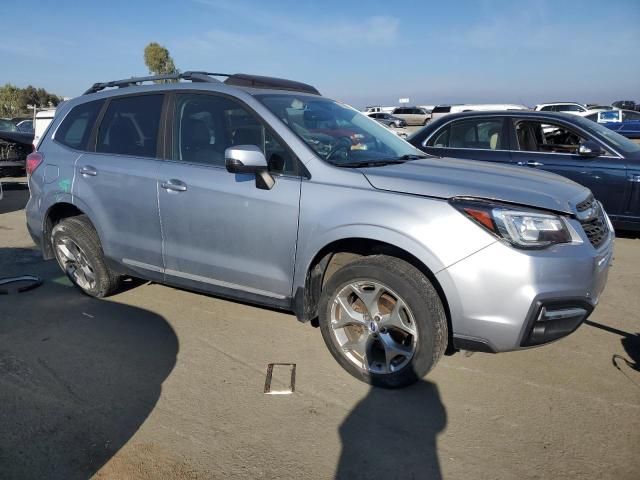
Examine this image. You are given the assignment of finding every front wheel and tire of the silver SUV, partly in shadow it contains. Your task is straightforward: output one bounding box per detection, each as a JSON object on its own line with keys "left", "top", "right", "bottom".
{"left": 319, "top": 255, "right": 448, "bottom": 388}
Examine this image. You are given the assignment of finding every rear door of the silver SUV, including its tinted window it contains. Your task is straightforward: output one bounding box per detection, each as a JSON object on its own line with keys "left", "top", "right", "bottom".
{"left": 73, "top": 93, "right": 164, "bottom": 277}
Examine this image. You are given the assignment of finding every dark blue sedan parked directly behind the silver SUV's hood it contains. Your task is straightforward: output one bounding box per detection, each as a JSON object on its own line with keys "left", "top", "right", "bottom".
{"left": 408, "top": 112, "right": 640, "bottom": 230}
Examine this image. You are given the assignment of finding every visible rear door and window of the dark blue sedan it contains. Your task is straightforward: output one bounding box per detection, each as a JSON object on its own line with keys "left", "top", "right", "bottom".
{"left": 422, "top": 116, "right": 511, "bottom": 163}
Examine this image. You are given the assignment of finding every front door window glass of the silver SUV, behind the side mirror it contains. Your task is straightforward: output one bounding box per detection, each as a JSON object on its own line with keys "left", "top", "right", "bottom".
{"left": 172, "top": 94, "right": 298, "bottom": 175}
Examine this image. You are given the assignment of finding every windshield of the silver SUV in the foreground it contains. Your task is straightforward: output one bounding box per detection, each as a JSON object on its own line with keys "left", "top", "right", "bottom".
{"left": 257, "top": 94, "right": 426, "bottom": 167}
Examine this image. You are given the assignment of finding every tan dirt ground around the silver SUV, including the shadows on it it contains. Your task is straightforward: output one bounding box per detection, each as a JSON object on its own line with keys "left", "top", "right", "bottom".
{"left": 0, "top": 180, "right": 640, "bottom": 480}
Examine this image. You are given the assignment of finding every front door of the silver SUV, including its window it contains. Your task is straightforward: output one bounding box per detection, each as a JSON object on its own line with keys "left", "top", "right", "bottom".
{"left": 158, "top": 94, "right": 301, "bottom": 300}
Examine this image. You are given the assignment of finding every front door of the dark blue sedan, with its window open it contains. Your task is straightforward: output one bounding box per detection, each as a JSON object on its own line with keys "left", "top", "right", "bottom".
{"left": 512, "top": 118, "right": 628, "bottom": 216}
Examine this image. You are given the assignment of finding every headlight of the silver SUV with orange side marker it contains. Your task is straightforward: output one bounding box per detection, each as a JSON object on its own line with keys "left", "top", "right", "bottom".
{"left": 451, "top": 199, "right": 572, "bottom": 248}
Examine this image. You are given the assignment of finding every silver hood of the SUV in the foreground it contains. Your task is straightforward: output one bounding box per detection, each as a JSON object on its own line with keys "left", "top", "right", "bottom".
{"left": 361, "top": 157, "right": 590, "bottom": 213}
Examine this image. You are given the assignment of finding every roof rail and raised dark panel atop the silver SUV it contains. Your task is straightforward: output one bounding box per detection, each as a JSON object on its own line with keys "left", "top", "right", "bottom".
{"left": 83, "top": 71, "right": 320, "bottom": 95}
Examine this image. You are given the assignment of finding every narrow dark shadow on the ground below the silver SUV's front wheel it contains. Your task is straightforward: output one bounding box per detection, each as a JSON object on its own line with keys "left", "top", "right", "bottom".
{"left": 336, "top": 380, "right": 447, "bottom": 480}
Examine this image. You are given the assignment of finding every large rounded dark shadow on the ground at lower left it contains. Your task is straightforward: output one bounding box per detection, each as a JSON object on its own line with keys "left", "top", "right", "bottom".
{"left": 0, "top": 248, "right": 178, "bottom": 479}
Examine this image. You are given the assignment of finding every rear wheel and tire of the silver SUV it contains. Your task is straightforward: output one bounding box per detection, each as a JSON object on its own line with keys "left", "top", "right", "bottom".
{"left": 51, "top": 215, "right": 120, "bottom": 298}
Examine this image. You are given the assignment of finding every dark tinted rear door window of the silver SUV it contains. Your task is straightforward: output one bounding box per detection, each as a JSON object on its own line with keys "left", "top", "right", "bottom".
{"left": 96, "top": 94, "right": 164, "bottom": 157}
